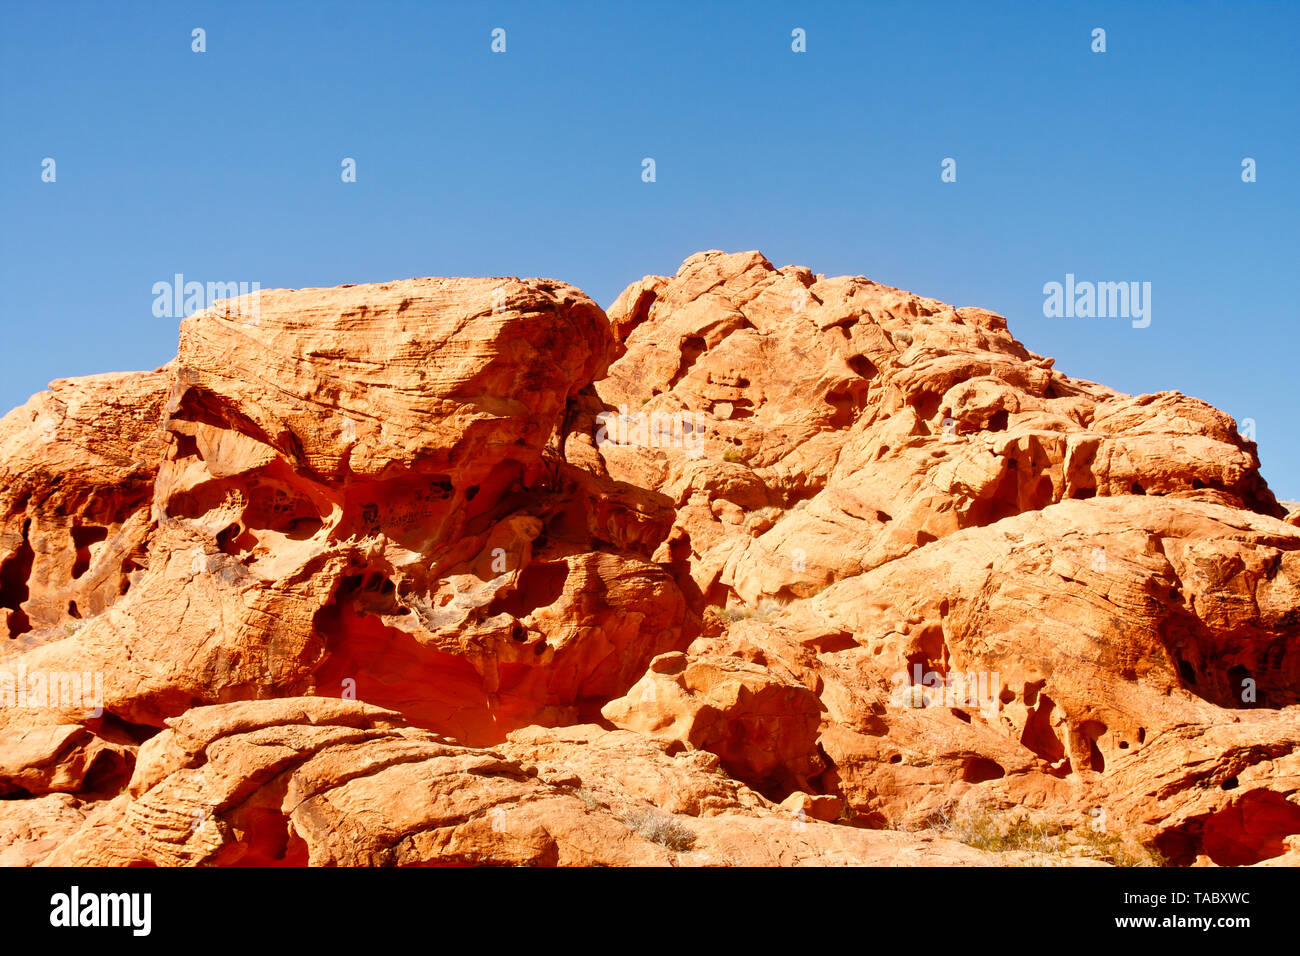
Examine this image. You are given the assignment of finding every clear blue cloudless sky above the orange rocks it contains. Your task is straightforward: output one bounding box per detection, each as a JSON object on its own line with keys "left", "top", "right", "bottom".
{"left": 0, "top": 0, "right": 1300, "bottom": 498}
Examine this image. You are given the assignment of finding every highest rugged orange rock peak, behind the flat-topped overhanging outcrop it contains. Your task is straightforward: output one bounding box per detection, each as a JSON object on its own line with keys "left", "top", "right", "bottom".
{"left": 598, "top": 252, "right": 1282, "bottom": 604}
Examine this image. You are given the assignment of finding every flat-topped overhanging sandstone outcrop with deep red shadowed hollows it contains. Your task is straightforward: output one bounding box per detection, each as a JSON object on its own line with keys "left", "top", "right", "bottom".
{"left": 0, "top": 280, "right": 685, "bottom": 764}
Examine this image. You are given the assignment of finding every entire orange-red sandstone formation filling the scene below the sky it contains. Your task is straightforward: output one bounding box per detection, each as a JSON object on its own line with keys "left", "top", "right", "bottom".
{"left": 0, "top": 252, "right": 1300, "bottom": 865}
